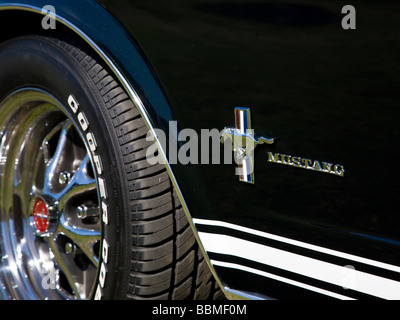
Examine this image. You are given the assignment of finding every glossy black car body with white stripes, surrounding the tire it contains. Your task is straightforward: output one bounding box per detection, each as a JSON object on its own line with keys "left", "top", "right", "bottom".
{"left": 0, "top": 0, "right": 400, "bottom": 299}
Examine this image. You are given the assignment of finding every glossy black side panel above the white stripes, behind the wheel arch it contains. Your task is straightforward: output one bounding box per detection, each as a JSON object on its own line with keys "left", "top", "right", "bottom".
{"left": 102, "top": 0, "right": 400, "bottom": 295}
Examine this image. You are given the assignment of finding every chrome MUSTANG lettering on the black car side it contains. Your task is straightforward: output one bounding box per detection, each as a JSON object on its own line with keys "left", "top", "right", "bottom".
{"left": 268, "top": 152, "right": 345, "bottom": 177}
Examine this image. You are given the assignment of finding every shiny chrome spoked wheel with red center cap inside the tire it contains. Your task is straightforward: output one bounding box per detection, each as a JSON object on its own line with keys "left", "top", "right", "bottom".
{"left": 0, "top": 89, "right": 101, "bottom": 299}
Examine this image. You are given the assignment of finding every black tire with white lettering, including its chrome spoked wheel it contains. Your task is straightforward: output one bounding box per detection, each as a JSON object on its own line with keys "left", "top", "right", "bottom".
{"left": 0, "top": 35, "right": 222, "bottom": 299}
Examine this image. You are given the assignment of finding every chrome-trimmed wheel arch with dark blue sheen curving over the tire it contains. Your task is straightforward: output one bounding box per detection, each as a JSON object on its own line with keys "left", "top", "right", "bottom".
{"left": 0, "top": 0, "right": 230, "bottom": 299}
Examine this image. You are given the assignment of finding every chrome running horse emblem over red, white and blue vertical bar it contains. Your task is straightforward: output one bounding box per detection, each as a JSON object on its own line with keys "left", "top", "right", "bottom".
{"left": 221, "top": 107, "right": 276, "bottom": 184}
